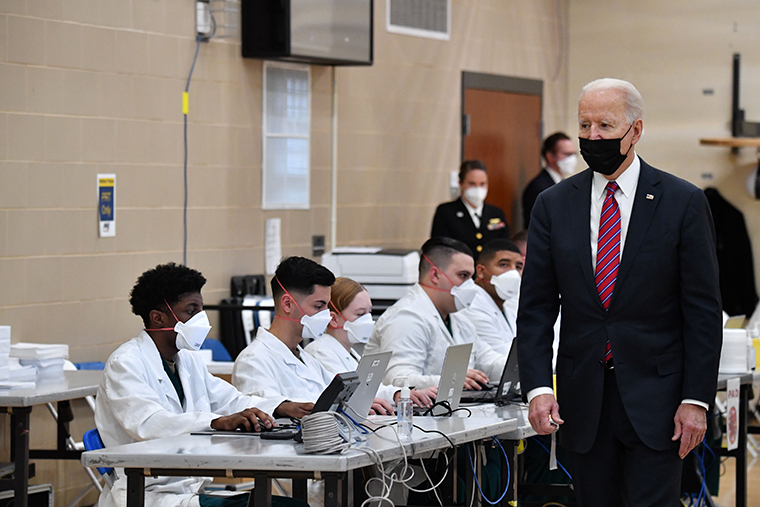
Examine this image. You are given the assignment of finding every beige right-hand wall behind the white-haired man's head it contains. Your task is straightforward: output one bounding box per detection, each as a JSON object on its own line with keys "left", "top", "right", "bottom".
{"left": 567, "top": 0, "right": 760, "bottom": 302}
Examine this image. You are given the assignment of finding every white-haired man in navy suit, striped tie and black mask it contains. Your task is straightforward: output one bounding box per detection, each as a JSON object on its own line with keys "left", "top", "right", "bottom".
{"left": 517, "top": 79, "right": 721, "bottom": 507}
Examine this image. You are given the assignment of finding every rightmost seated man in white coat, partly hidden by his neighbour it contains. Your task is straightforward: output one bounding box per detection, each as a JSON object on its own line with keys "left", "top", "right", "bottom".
{"left": 462, "top": 239, "right": 523, "bottom": 355}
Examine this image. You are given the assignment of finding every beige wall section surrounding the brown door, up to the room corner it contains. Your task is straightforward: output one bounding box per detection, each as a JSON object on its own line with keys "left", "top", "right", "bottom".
{"left": 337, "top": 0, "right": 567, "bottom": 248}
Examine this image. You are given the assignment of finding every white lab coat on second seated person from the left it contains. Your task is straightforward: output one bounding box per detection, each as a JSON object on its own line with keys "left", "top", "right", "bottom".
{"left": 232, "top": 327, "right": 334, "bottom": 408}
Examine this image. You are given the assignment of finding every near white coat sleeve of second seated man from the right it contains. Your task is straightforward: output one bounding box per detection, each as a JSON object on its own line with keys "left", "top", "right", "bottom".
{"left": 372, "top": 310, "right": 441, "bottom": 389}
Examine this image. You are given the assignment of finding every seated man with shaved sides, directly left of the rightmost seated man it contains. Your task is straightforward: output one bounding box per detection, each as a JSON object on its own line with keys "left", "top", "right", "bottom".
{"left": 364, "top": 238, "right": 507, "bottom": 390}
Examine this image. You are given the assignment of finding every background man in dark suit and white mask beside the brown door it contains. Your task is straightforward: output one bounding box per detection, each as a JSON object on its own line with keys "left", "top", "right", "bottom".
{"left": 522, "top": 132, "right": 578, "bottom": 229}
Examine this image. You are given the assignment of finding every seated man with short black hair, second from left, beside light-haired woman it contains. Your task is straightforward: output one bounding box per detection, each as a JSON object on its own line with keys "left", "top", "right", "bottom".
{"left": 232, "top": 257, "right": 392, "bottom": 418}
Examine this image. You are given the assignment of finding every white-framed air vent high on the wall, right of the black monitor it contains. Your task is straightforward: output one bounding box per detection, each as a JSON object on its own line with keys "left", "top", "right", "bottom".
{"left": 386, "top": 0, "right": 451, "bottom": 40}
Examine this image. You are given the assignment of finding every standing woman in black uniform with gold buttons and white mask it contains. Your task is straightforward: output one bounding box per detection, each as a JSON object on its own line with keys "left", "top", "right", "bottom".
{"left": 430, "top": 160, "right": 509, "bottom": 259}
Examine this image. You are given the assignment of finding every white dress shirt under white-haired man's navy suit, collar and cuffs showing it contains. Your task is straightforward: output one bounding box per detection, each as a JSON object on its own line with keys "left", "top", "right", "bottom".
{"left": 528, "top": 153, "right": 708, "bottom": 410}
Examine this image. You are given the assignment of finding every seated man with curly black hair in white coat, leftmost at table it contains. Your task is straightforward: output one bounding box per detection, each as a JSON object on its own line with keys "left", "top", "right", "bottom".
{"left": 95, "top": 263, "right": 306, "bottom": 507}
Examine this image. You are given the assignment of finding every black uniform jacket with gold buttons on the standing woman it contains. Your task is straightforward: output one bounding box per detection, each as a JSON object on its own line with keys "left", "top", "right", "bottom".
{"left": 430, "top": 197, "right": 509, "bottom": 259}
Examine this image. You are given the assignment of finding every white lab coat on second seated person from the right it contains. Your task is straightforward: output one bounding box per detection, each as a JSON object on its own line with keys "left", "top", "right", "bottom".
{"left": 364, "top": 284, "right": 507, "bottom": 389}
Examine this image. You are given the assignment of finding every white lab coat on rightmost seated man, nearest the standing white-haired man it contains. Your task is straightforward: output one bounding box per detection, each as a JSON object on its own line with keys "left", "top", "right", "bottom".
{"left": 459, "top": 286, "right": 516, "bottom": 358}
